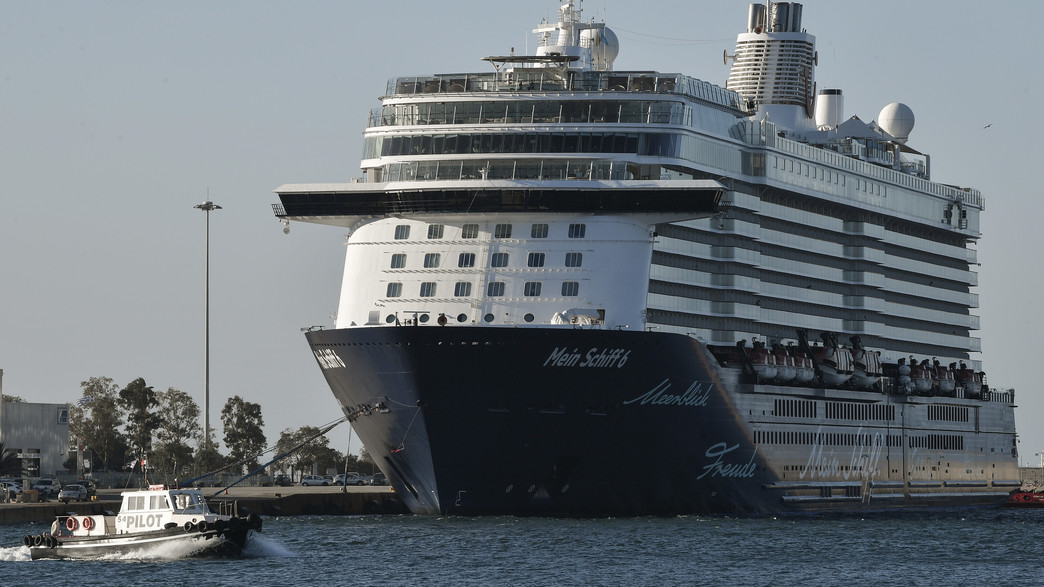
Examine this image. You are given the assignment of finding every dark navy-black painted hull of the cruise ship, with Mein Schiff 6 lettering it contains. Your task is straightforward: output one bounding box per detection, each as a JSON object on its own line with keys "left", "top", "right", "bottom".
{"left": 308, "top": 327, "right": 1006, "bottom": 516}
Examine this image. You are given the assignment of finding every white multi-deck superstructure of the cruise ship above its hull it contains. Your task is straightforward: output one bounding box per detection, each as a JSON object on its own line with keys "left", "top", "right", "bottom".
{"left": 278, "top": 2, "right": 983, "bottom": 365}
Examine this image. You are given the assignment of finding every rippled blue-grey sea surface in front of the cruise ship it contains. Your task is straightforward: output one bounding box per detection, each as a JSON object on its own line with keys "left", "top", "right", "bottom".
{"left": 0, "top": 510, "right": 1044, "bottom": 587}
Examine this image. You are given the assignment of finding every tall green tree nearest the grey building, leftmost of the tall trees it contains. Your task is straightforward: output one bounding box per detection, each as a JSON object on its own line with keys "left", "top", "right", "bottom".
{"left": 69, "top": 377, "right": 126, "bottom": 469}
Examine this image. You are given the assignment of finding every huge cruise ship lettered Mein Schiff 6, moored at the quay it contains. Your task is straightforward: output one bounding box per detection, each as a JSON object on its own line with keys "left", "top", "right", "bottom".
{"left": 274, "top": 0, "right": 1020, "bottom": 516}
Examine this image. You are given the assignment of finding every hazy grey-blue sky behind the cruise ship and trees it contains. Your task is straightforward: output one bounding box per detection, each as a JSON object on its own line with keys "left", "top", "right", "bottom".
{"left": 0, "top": 0, "right": 1044, "bottom": 464}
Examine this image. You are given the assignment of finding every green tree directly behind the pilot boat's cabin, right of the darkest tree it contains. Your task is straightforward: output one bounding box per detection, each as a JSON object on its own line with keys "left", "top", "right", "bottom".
{"left": 149, "top": 388, "right": 201, "bottom": 482}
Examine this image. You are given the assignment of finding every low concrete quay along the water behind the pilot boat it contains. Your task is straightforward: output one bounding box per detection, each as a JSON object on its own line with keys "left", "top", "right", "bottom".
{"left": 0, "top": 486, "right": 409, "bottom": 524}
